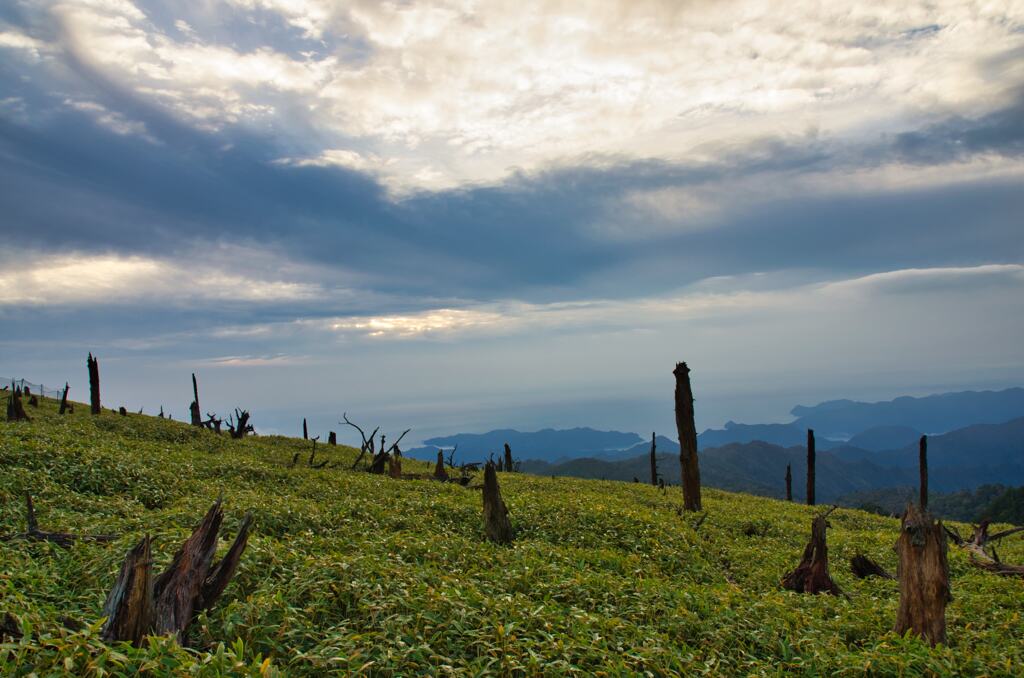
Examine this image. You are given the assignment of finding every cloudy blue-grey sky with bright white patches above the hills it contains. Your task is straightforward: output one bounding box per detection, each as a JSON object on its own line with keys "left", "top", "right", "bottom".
{"left": 0, "top": 0, "right": 1024, "bottom": 441}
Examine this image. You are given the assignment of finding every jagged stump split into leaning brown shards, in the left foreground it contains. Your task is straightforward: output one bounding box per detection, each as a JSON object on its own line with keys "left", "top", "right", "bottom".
{"left": 102, "top": 500, "right": 252, "bottom": 645}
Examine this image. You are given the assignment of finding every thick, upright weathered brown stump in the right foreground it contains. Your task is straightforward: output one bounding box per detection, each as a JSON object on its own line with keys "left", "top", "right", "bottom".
{"left": 895, "top": 504, "right": 952, "bottom": 645}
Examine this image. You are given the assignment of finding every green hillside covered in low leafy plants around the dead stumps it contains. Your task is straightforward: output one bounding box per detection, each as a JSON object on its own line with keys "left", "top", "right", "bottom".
{"left": 0, "top": 399, "right": 1024, "bottom": 676}
